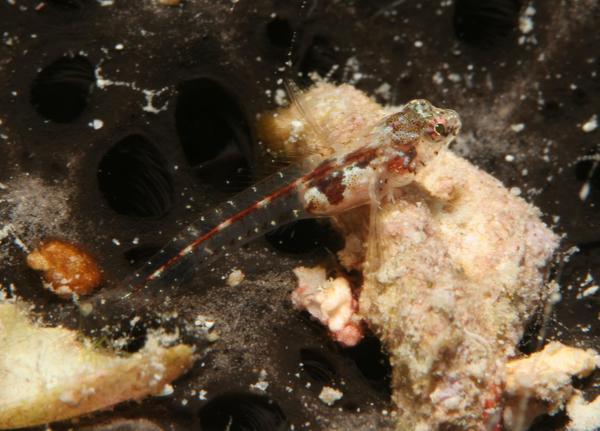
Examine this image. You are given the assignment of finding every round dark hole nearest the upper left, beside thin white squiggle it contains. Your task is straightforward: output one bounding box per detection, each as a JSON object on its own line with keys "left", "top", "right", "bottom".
{"left": 30, "top": 55, "right": 95, "bottom": 123}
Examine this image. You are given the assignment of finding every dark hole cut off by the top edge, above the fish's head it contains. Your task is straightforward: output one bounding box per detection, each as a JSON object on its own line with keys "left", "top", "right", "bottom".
{"left": 454, "top": 0, "right": 521, "bottom": 46}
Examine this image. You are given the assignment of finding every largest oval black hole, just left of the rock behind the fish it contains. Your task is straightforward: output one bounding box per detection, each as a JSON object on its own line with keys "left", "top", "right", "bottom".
{"left": 175, "top": 78, "right": 253, "bottom": 190}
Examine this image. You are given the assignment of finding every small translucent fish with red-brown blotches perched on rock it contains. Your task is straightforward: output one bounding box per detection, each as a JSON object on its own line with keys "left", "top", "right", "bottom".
{"left": 113, "top": 99, "right": 461, "bottom": 296}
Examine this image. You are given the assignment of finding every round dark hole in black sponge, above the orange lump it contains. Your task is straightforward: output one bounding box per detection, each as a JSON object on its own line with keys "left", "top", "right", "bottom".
{"left": 98, "top": 135, "right": 174, "bottom": 217}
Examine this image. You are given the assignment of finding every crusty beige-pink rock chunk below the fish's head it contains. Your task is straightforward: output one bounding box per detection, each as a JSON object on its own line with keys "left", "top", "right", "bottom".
{"left": 359, "top": 151, "right": 557, "bottom": 430}
